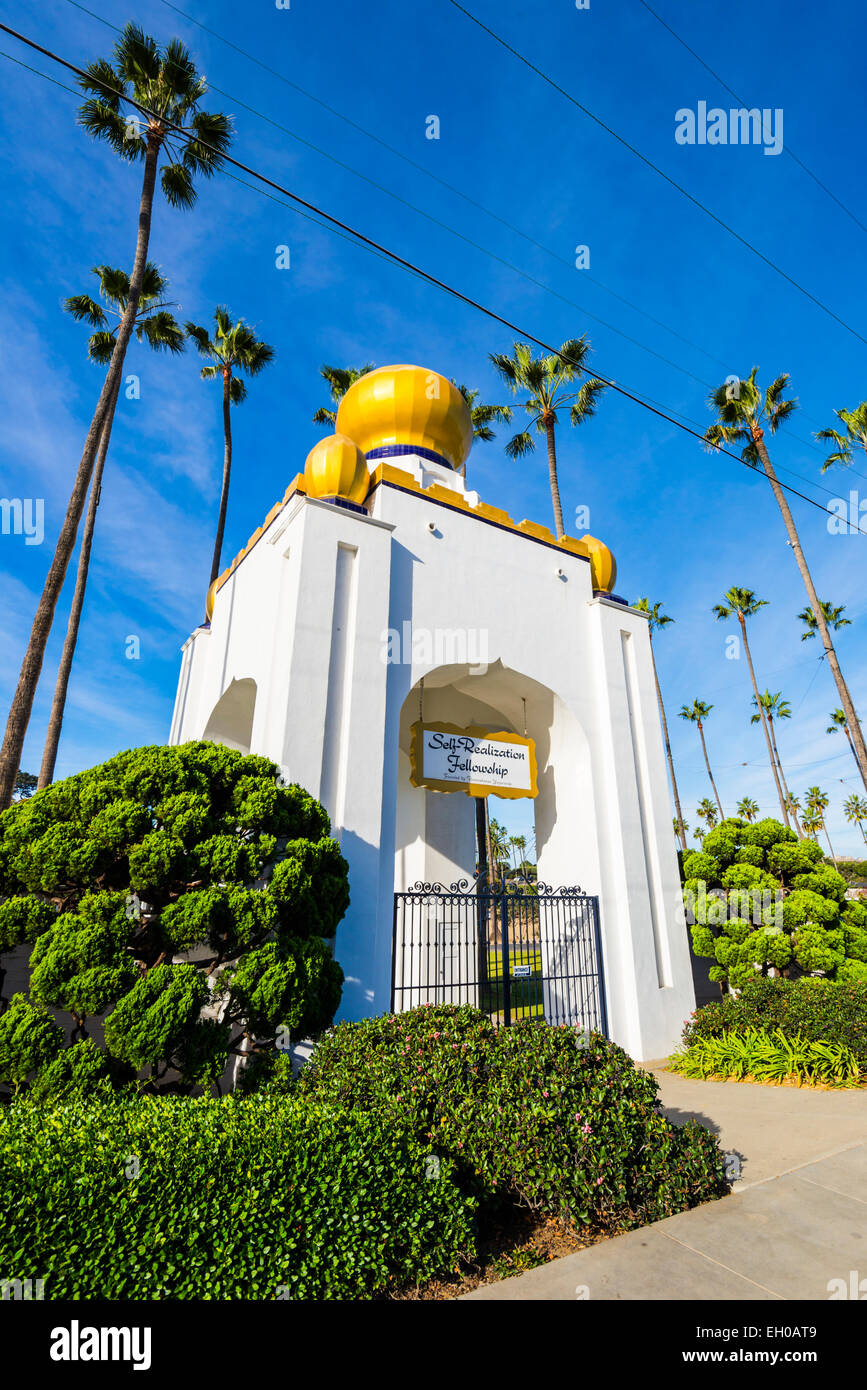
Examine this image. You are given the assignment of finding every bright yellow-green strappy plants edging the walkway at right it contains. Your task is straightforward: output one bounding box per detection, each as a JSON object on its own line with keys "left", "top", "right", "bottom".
{"left": 670, "top": 1027, "right": 861, "bottom": 1086}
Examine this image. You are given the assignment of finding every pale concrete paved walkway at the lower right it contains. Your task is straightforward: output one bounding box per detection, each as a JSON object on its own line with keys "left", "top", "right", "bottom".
{"left": 464, "top": 1063, "right": 867, "bottom": 1301}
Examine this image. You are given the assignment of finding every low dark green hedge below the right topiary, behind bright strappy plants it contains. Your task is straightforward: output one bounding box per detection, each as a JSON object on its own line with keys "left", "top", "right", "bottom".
{"left": 684, "top": 976, "right": 867, "bottom": 1068}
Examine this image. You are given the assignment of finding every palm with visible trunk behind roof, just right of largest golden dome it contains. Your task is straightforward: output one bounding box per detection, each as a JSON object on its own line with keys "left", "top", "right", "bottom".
{"left": 490, "top": 336, "right": 606, "bottom": 539}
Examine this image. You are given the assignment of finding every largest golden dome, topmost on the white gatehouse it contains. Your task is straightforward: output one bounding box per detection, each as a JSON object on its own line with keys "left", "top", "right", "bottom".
{"left": 338, "top": 366, "right": 472, "bottom": 468}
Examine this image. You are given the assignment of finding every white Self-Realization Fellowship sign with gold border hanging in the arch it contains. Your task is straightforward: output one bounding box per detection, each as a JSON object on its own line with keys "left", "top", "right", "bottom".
{"left": 410, "top": 720, "right": 539, "bottom": 796}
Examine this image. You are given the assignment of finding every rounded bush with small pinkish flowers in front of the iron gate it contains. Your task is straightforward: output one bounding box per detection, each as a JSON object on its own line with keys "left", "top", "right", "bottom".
{"left": 297, "top": 1006, "right": 725, "bottom": 1229}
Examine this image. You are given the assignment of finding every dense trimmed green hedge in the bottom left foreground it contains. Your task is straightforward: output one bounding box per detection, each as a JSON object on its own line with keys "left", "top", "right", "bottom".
{"left": 0, "top": 1094, "right": 475, "bottom": 1300}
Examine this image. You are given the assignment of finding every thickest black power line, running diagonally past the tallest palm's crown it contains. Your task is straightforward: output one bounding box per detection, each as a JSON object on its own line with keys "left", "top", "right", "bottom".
{"left": 0, "top": 22, "right": 867, "bottom": 535}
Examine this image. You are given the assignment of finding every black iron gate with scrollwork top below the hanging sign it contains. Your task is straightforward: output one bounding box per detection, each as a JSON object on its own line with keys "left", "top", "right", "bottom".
{"left": 392, "top": 878, "right": 609, "bottom": 1037}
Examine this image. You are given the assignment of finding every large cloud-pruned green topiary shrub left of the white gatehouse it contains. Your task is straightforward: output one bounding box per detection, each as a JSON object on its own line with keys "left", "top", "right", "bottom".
{"left": 0, "top": 742, "right": 349, "bottom": 1097}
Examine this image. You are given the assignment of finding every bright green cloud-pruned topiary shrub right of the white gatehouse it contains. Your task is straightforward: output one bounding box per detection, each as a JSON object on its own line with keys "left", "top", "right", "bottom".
{"left": 684, "top": 819, "right": 867, "bottom": 988}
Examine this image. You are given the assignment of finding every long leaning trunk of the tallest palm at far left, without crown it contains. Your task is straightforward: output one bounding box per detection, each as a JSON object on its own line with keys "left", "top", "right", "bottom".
{"left": 0, "top": 132, "right": 161, "bottom": 810}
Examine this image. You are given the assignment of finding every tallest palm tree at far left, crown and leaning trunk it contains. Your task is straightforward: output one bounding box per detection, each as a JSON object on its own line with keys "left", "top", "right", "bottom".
{"left": 0, "top": 24, "right": 231, "bottom": 810}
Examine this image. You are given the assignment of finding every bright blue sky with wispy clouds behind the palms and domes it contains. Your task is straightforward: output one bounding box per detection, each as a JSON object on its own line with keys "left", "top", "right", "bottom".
{"left": 0, "top": 0, "right": 867, "bottom": 853}
